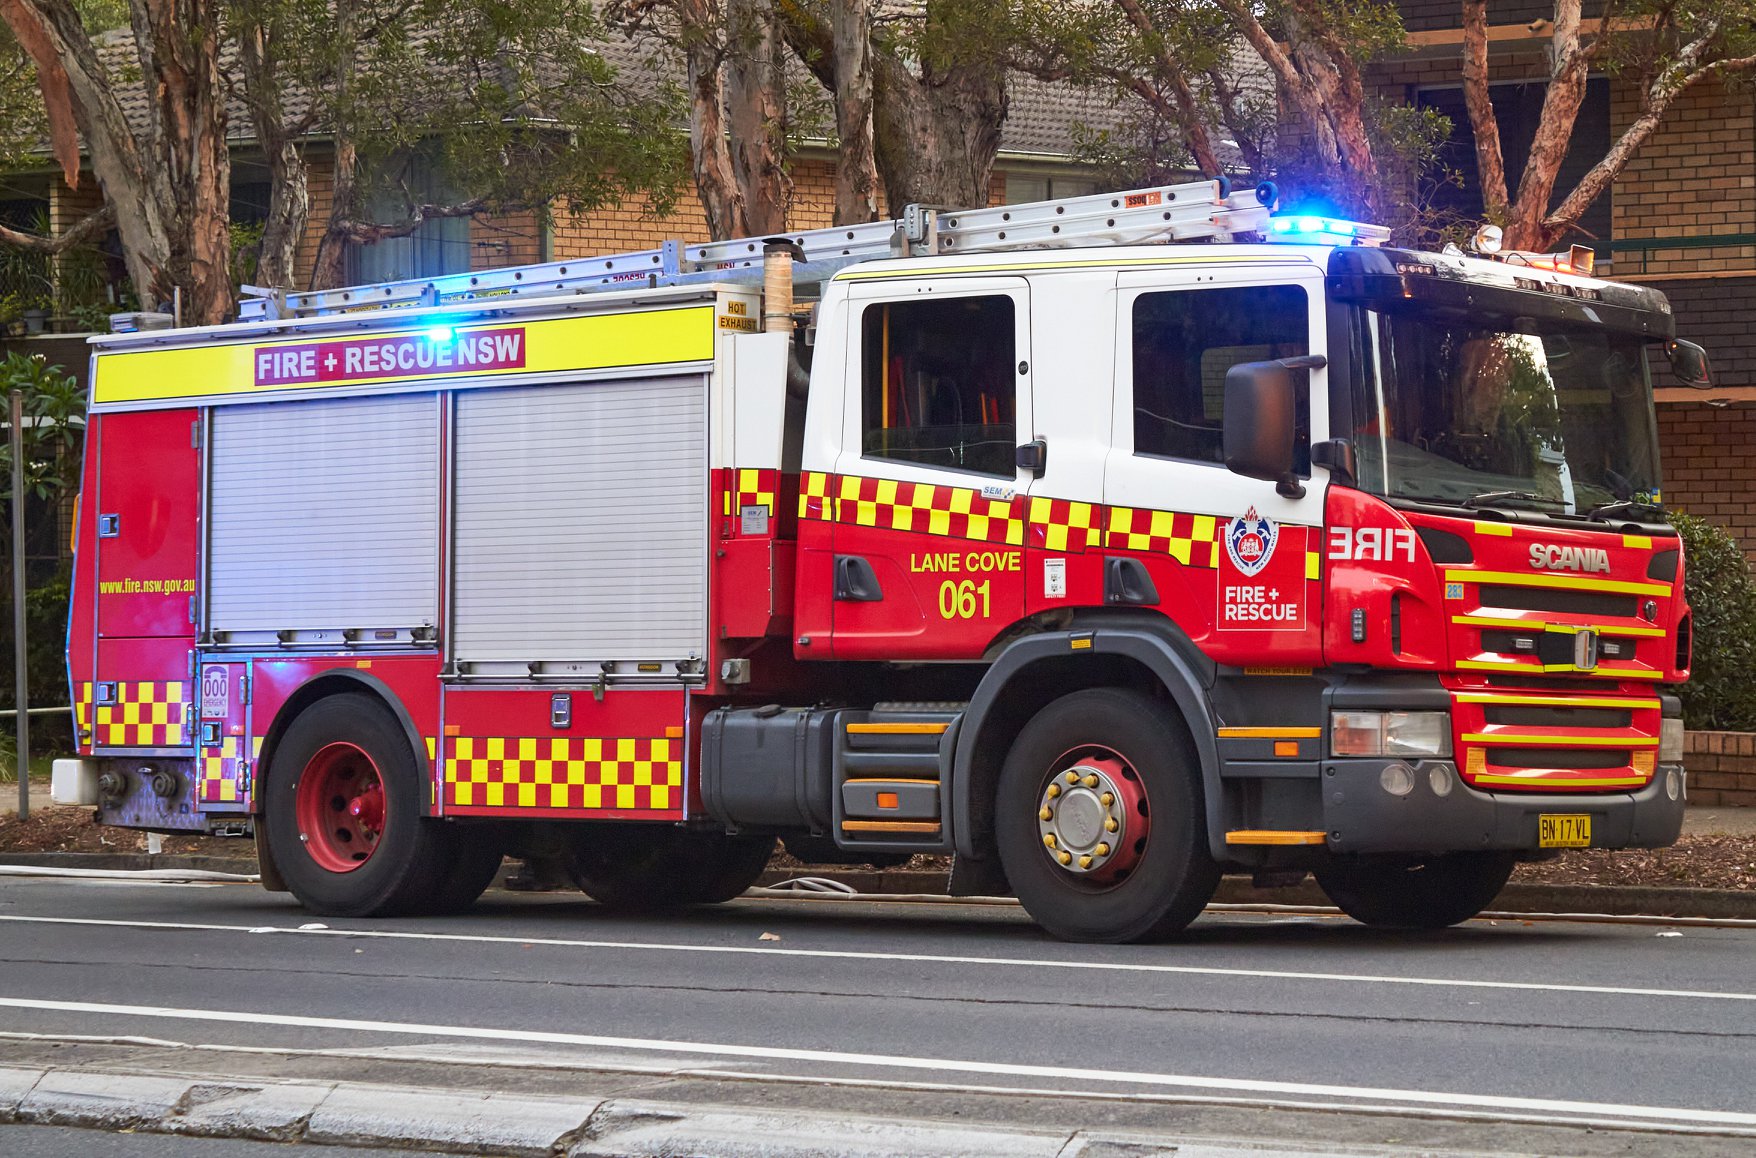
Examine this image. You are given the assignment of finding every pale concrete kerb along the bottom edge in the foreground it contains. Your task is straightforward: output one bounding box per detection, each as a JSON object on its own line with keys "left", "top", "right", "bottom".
{"left": 0, "top": 1067, "right": 1361, "bottom": 1158}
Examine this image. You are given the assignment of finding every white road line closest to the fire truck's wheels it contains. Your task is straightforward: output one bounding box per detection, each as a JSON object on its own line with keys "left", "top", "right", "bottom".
{"left": 0, "top": 914, "right": 1756, "bottom": 1002}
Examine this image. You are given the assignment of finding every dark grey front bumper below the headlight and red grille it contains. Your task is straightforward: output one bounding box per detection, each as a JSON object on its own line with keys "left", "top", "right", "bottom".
{"left": 1322, "top": 759, "right": 1688, "bottom": 852}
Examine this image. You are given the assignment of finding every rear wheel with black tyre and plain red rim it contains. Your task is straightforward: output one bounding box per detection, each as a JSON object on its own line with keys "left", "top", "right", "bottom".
{"left": 263, "top": 694, "right": 457, "bottom": 917}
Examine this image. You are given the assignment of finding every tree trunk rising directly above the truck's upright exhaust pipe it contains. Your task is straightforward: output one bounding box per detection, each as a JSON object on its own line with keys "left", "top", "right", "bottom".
{"left": 725, "top": 0, "right": 788, "bottom": 237}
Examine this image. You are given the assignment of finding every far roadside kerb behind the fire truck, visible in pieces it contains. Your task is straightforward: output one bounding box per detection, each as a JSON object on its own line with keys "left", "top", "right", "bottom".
{"left": 0, "top": 852, "right": 1756, "bottom": 921}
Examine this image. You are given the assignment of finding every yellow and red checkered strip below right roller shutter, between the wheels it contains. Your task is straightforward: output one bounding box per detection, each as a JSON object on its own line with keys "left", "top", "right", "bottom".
{"left": 444, "top": 736, "right": 683, "bottom": 812}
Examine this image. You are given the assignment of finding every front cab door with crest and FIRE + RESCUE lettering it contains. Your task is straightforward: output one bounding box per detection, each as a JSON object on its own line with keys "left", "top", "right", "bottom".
{"left": 1105, "top": 264, "right": 1328, "bottom": 666}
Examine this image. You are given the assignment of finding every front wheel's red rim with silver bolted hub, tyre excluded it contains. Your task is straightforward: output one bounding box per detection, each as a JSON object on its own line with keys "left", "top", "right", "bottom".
{"left": 1036, "top": 749, "right": 1152, "bottom": 884}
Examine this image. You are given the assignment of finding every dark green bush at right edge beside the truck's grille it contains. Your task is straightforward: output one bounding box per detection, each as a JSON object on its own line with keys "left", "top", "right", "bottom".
{"left": 1670, "top": 511, "right": 1756, "bottom": 731}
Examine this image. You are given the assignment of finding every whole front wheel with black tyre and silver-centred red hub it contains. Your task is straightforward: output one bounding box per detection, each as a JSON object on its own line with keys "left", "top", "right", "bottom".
{"left": 994, "top": 687, "right": 1219, "bottom": 942}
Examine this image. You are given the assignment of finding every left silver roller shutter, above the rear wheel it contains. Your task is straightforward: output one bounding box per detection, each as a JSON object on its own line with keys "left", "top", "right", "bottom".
{"left": 209, "top": 394, "right": 441, "bottom": 643}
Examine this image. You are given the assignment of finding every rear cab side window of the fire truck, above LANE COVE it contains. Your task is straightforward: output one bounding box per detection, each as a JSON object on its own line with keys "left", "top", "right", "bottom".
{"left": 860, "top": 295, "right": 1017, "bottom": 478}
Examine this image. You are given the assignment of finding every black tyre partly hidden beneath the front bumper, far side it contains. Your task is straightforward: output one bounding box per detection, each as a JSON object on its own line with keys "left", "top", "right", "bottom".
{"left": 1312, "top": 852, "right": 1514, "bottom": 930}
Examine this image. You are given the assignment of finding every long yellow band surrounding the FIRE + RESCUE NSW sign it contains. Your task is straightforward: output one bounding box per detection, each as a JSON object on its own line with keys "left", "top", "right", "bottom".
{"left": 91, "top": 306, "right": 713, "bottom": 406}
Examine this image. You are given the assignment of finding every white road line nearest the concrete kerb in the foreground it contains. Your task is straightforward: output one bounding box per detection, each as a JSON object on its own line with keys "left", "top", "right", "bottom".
{"left": 0, "top": 998, "right": 1756, "bottom": 1126}
